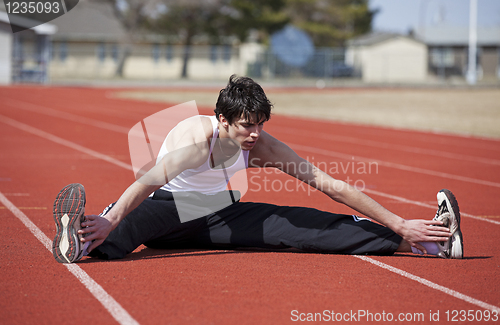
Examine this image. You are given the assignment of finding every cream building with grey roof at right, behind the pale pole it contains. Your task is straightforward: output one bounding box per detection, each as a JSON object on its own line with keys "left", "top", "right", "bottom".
{"left": 346, "top": 27, "right": 500, "bottom": 83}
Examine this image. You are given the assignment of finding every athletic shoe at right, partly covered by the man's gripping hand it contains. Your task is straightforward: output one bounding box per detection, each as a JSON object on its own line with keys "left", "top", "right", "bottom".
{"left": 434, "top": 189, "right": 464, "bottom": 258}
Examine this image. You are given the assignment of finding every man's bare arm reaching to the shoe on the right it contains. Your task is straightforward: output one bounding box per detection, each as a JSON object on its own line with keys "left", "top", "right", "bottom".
{"left": 250, "top": 132, "right": 450, "bottom": 251}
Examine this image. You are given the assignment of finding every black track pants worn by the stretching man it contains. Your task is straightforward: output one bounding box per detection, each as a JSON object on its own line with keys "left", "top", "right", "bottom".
{"left": 90, "top": 190, "right": 401, "bottom": 259}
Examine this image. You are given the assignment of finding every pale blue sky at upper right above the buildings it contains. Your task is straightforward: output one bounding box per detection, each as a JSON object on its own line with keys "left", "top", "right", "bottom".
{"left": 369, "top": 0, "right": 500, "bottom": 34}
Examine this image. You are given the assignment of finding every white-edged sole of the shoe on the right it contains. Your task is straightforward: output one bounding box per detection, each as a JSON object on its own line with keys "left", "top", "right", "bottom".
{"left": 437, "top": 189, "right": 464, "bottom": 259}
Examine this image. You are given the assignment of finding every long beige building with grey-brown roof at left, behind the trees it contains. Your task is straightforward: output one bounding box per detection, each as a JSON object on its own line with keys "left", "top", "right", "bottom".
{"left": 46, "top": 1, "right": 248, "bottom": 80}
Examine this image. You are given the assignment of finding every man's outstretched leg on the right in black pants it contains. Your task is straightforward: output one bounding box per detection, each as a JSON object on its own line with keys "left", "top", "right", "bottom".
{"left": 198, "top": 202, "right": 402, "bottom": 255}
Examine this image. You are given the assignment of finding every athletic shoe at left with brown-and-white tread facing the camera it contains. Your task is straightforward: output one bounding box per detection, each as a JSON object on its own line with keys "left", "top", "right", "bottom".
{"left": 52, "top": 184, "right": 88, "bottom": 263}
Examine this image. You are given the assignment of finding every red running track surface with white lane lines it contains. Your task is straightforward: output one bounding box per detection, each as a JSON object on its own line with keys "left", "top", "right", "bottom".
{"left": 0, "top": 87, "right": 500, "bottom": 324}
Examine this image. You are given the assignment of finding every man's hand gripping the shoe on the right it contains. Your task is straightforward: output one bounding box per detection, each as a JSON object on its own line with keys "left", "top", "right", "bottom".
{"left": 400, "top": 220, "right": 451, "bottom": 254}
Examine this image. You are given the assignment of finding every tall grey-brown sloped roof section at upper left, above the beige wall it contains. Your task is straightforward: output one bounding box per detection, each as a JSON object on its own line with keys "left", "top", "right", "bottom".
{"left": 52, "top": 0, "right": 127, "bottom": 41}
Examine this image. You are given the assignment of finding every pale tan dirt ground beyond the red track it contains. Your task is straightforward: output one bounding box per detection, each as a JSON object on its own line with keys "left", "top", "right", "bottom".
{"left": 114, "top": 88, "right": 500, "bottom": 139}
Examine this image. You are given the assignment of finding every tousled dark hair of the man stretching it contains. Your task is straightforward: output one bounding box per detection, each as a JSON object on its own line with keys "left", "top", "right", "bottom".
{"left": 214, "top": 75, "right": 273, "bottom": 124}
